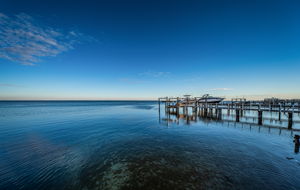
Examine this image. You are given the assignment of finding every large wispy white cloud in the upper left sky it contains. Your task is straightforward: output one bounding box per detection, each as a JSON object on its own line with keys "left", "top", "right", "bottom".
{"left": 0, "top": 13, "right": 94, "bottom": 65}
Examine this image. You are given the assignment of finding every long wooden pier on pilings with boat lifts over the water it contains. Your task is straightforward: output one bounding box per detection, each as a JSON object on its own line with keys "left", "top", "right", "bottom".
{"left": 158, "top": 95, "right": 300, "bottom": 130}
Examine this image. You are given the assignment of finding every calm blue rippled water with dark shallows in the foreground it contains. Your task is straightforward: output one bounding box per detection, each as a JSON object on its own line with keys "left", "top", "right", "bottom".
{"left": 0, "top": 102, "right": 300, "bottom": 190}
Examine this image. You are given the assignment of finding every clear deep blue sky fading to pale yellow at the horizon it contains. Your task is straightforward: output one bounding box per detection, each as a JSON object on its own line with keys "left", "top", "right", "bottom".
{"left": 0, "top": 0, "right": 300, "bottom": 100}
